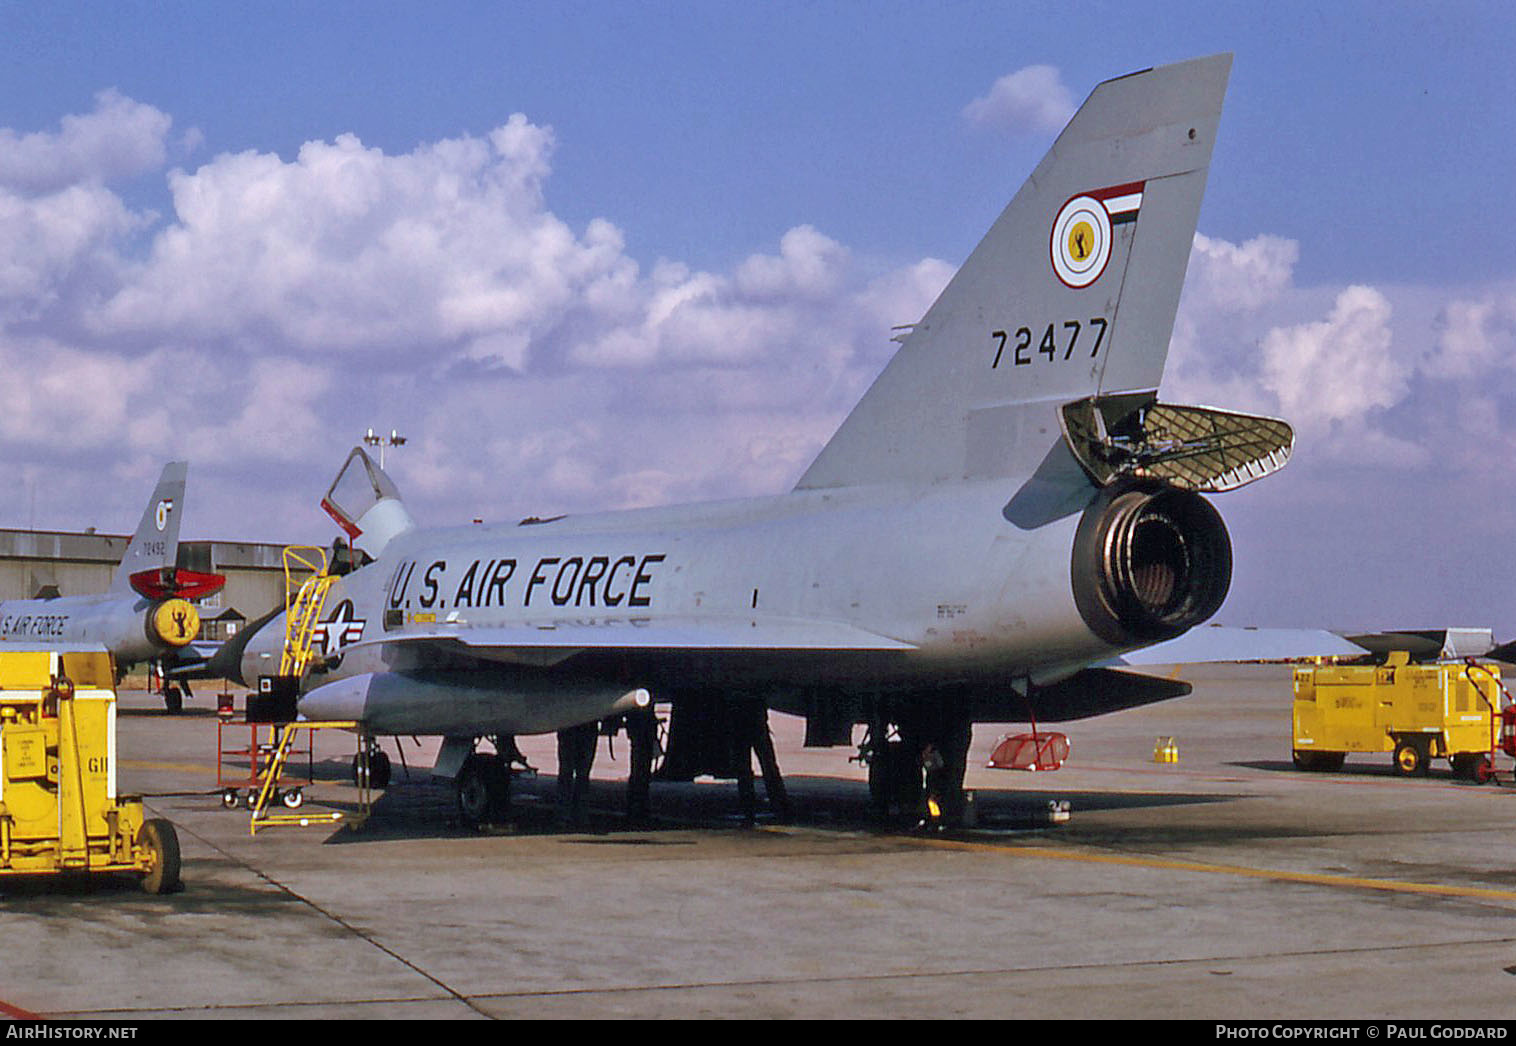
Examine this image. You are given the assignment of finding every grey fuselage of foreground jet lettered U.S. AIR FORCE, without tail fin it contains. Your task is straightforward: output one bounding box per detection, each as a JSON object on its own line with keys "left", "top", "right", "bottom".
{"left": 243, "top": 463, "right": 1218, "bottom": 734}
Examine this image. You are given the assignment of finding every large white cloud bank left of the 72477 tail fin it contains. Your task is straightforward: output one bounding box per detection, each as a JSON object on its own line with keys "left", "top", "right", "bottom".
{"left": 0, "top": 94, "right": 949, "bottom": 535}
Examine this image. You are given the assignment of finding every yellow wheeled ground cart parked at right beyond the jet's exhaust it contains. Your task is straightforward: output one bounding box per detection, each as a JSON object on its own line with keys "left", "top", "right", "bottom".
{"left": 1293, "top": 652, "right": 1502, "bottom": 782}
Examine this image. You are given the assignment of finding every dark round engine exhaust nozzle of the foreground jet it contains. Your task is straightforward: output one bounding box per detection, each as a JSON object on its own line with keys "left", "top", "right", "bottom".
{"left": 1072, "top": 481, "right": 1233, "bottom": 646}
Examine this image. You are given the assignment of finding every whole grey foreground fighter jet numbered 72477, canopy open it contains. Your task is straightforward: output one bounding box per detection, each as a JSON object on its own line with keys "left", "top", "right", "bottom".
{"left": 216, "top": 55, "right": 1340, "bottom": 813}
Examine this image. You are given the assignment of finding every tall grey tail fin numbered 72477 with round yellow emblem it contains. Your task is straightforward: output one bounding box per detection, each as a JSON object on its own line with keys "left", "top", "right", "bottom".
{"left": 799, "top": 55, "right": 1231, "bottom": 488}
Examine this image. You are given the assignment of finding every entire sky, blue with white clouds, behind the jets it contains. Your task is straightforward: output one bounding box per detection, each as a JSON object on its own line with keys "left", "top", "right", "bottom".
{"left": 0, "top": 3, "right": 1516, "bottom": 637}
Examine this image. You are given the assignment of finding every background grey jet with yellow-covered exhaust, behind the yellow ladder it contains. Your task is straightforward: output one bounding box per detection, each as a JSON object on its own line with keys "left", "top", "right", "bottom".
{"left": 0, "top": 461, "right": 224, "bottom": 712}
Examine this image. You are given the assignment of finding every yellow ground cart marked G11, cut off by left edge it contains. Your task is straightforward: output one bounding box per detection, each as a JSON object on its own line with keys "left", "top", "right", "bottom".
{"left": 0, "top": 650, "right": 179, "bottom": 893}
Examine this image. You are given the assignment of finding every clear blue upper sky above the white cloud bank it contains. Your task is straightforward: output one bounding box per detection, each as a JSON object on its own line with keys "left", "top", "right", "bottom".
{"left": 14, "top": 0, "right": 1516, "bottom": 280}
